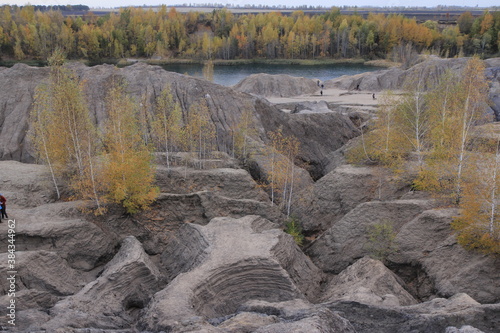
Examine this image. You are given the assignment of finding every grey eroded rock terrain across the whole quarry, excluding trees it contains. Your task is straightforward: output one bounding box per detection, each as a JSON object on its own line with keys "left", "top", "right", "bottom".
{"left": 0, "top": 59, "right": 500, "bottom": 333}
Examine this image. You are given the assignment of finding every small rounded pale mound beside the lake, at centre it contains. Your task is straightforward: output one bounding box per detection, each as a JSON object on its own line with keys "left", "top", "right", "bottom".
{"left": 233, "top": 73, "right": 320, "bottom": 97}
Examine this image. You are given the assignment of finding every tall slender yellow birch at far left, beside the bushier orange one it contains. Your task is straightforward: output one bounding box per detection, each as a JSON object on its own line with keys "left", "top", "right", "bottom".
{"left": 31, "top": 52, "right": 102, "bottom": 210}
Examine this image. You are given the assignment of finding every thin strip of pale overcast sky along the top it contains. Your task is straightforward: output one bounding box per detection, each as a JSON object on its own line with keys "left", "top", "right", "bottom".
{"left": 0, "top": 0, "right": 494, "bottom": 8}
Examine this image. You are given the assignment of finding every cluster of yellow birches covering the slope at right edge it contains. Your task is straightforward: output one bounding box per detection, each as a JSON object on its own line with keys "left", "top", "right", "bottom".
{"left": 348, "top": 58, "right": 500, "bottom": 254}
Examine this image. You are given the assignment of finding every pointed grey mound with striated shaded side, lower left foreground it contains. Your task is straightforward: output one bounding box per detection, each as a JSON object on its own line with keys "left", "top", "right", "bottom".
{"left": 41, "top": 236, "right": 160, "bottom": 331}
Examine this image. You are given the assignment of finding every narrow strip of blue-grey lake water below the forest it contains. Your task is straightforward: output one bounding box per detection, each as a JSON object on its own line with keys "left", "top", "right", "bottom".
{"left": 162, "top": 64, "right": 382, "bottom": 86}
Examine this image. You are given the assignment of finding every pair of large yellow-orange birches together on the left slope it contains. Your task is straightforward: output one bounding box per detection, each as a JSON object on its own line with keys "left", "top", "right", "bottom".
{"left": 31, "top": 54, "right": 157, "bottom": 215}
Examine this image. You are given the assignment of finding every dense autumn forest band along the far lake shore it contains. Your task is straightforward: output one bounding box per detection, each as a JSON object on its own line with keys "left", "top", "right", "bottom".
{"left": 0, "top": 5, "right": 500, "bottom": 60}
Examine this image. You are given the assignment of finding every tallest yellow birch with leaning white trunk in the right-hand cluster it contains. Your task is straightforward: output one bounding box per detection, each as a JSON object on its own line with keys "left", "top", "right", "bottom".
{"left": 416, "top": 58, "right": 489, "bottom": 204}
